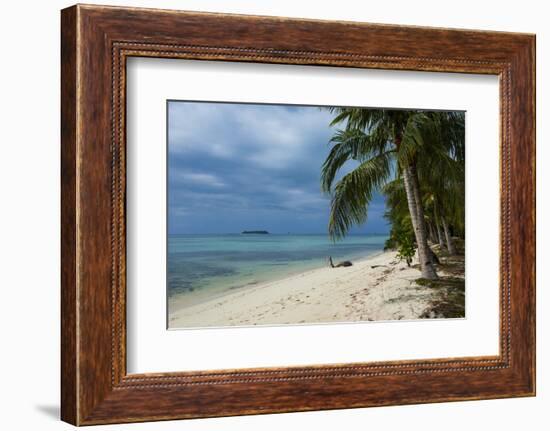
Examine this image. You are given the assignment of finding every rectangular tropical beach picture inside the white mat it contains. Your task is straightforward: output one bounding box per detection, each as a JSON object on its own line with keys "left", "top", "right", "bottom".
{"left": 166, "top": 100, "right": 466, "bottom": 329}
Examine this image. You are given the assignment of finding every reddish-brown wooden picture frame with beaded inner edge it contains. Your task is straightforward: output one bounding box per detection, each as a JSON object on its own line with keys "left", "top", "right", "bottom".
{"left": 61, "top": 5, "right": 535, "bottom": 425}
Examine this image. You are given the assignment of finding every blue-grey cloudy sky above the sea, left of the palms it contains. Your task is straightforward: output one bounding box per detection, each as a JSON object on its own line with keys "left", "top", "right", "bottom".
{"left": 168, "top": 101, "right": 388, "bottom": 234}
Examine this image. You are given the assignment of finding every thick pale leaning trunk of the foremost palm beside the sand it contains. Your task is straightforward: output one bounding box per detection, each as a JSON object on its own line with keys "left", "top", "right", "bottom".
{"left": 403, "top": 164, "right": 437, "bottom": 280}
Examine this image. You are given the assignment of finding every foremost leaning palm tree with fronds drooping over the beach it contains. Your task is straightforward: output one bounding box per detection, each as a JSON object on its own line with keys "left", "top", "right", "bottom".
{"left": 321, "top": 108, "right": 437, "bottom": 279}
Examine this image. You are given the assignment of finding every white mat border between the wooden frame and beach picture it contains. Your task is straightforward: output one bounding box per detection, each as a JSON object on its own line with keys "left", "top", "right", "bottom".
{"left": 127, "top": 58, "right": 500, "bottom": 373}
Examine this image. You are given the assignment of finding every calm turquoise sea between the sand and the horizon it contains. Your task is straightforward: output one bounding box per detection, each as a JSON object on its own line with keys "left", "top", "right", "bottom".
{"left": 168, "top": 234, "right": 387, "bottom": 305}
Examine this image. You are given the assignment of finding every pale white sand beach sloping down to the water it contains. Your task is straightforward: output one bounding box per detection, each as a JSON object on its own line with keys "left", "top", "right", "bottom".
{"left": 169, "top": 251, "right": 462, "bottom": 328}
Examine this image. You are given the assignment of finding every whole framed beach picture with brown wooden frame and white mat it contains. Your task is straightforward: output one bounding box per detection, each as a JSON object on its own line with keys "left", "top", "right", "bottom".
{"left": 61, "top": 5, "right": 535, "bottom": 425}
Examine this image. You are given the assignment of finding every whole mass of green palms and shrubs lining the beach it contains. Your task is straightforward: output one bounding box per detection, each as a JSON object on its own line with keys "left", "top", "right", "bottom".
{"left": 321, "top": 107, "right": 465, "bottom": 280}
